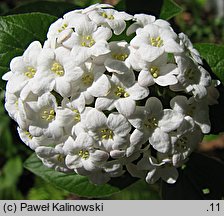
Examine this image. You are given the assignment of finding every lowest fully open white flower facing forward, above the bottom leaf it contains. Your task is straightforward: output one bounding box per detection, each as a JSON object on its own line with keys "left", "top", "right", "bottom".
{"left": 64, "top": 133, "right": 109, "bottom": 172}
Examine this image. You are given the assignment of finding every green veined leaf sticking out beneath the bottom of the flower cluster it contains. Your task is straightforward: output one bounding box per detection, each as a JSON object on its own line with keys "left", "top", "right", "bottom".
{"left": 24, "top": 154, "right": 124, "bottom": 198}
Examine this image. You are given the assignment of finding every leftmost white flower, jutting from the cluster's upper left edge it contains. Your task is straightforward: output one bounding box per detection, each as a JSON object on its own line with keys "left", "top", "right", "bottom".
{"left": 2, "top": 41, "right": 42, "bottom": 94}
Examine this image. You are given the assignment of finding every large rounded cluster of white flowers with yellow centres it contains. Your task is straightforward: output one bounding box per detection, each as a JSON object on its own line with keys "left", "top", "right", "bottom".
{"left": 3, "top": 4, "right": 218, "bottom": 184}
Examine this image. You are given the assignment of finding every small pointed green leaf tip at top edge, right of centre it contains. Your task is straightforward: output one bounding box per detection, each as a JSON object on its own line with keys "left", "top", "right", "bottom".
{"left": 160, "top": 0, "right": 183, "bottom": 20}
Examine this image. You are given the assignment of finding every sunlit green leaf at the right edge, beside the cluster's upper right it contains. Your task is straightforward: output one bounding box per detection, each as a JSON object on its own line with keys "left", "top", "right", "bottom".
{"left": 194, "top": 43, "right": 224, "bottom": 84}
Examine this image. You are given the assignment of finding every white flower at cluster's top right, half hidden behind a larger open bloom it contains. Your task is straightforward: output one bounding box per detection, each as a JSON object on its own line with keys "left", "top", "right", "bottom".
{"left": 127, "top": 14, "right": 170, "bottom": 35}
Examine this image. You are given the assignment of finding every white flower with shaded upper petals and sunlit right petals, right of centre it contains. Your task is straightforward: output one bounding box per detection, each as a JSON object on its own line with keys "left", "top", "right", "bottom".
{"left": 128, "top": 97, "right": 183, "bottom": 153}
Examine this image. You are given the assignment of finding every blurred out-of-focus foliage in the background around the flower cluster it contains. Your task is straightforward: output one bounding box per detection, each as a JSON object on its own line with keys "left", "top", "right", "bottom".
{"left": 0, "top": 0, "right": 224, "bottom": 200}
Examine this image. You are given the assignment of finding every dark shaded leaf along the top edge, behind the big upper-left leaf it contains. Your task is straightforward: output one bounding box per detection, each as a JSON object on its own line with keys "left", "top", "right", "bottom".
{"left": 7, "top": 1, "right": 79, "bottom": 17}
